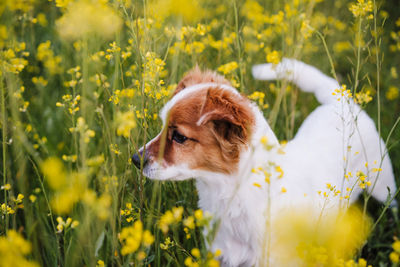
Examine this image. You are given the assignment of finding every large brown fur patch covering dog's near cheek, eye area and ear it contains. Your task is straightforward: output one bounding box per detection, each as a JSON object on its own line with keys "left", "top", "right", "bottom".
{"left": 148, "top": 84, "right": 254, "bottom": 174}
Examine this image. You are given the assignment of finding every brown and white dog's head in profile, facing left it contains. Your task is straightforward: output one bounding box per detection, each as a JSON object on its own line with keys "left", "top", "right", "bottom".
{"left": 132, "top": 67, "right": 254, "bottom": 180}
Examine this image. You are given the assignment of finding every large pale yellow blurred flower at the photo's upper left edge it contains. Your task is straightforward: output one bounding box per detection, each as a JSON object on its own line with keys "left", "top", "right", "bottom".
{"left": 57, "top": 0, "right": 122, "bottom": 40}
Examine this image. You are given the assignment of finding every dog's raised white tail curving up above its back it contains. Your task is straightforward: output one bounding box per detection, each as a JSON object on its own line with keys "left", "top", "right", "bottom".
{"left": 252, "top": 58, "right": 340, "bottom": 104}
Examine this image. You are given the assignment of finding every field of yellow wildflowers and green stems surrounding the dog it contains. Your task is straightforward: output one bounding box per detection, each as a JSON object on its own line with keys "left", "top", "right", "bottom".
{"left": 0, "top": 0, "right": 400, "bottom": 266}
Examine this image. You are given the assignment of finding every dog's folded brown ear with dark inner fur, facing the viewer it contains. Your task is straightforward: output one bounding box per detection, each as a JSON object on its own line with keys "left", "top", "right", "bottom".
{"left": 197, "top": 88, "right": 254, "bottom": 158}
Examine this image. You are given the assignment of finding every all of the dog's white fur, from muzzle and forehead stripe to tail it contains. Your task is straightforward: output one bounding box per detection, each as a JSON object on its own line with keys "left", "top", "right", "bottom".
{"left": 144, "top": 59, "right": 396, "bottom": 266}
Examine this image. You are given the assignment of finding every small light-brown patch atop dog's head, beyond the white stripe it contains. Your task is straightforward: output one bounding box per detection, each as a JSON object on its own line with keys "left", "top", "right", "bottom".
{"left": 174, "top": 65, "right": 231, "bottom": 95}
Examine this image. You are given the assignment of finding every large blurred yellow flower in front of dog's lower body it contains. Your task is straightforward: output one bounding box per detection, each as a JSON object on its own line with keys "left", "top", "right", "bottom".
{"left": 271, "top": 207, "right": 371, "bottom": 266}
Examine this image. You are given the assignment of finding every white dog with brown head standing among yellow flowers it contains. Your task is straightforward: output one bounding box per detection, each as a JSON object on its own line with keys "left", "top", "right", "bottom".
{"left": 132, "top": 59, "right": 396, "bottom": 266}
